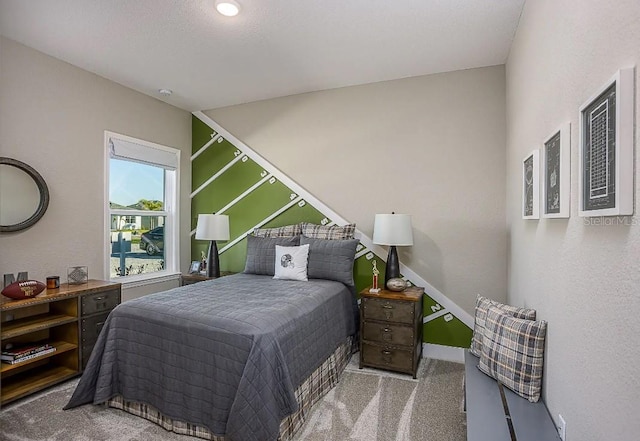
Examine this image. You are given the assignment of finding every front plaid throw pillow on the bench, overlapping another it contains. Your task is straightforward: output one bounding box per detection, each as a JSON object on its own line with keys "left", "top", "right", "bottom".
{"left": 478, "top": 306, "right": 547, "bottom": 403}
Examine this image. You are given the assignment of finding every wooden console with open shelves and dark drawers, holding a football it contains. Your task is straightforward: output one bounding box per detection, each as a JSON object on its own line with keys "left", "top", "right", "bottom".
{"left": 0, "top": 280, "right": 121, "bottom": 406}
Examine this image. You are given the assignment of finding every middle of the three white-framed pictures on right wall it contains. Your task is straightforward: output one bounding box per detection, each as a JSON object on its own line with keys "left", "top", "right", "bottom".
{"left": 541, "top": 122, "right": 571, "bottom": 218}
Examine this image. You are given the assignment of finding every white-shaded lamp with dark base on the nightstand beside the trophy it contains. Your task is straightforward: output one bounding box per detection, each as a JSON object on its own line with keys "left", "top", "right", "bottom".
{"left": 373, "top": 212, "right": 413, "bottom": 288}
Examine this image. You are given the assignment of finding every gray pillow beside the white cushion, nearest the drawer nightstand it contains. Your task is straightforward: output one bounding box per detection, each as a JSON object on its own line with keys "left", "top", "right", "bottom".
{"left": 300, "top": 236, "right": 360, "bottom": 286}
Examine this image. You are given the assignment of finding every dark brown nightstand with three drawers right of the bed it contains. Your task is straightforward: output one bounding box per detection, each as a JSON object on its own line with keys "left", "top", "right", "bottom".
{"left": 360, "top": 286, "right": 424, "bottom": 378}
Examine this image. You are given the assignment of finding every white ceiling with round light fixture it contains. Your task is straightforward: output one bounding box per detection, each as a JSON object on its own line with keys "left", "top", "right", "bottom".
{"left": 0, "top": 0, "right": 525, "bottom": 111}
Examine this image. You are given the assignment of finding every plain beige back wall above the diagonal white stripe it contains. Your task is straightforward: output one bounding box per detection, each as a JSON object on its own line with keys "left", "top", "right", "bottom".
{"left": 205, "top": 66, "right": 507, "bottom": 313}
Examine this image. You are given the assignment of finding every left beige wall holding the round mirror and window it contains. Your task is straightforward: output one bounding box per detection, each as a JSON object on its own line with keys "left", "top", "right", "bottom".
{"left": 0, "top": 38, "right": 191, "bottom": 298}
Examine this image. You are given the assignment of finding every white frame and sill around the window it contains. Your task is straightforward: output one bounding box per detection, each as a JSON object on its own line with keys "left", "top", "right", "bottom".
{"left": 103, "top": 130, "right": 180, "bottom": 287}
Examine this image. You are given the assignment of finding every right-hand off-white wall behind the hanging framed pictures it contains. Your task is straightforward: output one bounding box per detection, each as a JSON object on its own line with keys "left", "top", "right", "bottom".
{"left": 507, "top": 0, "right": 640, "bottom": 441}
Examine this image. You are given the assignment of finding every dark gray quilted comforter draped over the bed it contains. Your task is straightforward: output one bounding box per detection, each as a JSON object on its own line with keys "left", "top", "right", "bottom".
{"left": 65, "top": 274, "right": 355, "bottom": 441}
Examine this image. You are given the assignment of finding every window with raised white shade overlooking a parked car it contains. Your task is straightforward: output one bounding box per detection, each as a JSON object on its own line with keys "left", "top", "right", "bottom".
{"left": 105, "top": 132, "right": 180, "bottom": 281}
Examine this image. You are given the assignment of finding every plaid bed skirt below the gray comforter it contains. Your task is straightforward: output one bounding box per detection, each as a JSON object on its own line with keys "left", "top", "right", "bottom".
{"left": 106, "top": 337, "right": 357, "bottom": 441}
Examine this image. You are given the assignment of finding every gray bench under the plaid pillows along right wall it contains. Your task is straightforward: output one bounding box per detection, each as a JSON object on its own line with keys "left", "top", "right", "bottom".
{"left": 464, "top": 350, "right": 560, "bottom": 441}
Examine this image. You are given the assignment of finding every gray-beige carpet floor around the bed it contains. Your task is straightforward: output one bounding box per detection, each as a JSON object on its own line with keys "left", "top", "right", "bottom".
{"left": 0, "top": 354, "right": 466, "bottom": 441}
